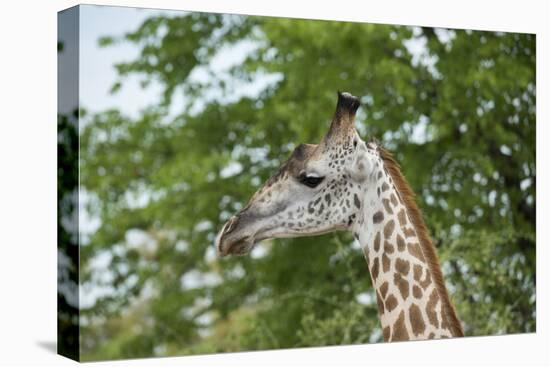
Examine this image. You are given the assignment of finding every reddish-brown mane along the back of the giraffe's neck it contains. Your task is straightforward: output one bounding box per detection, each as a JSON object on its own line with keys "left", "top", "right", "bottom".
{"left": 378, "top": 146, "right": 464, "bottom": 336}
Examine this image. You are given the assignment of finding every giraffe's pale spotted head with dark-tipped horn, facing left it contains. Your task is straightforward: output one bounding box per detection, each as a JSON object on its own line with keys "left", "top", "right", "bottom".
{"left": 216, "top": 92, "right": 371, "bottom": 256}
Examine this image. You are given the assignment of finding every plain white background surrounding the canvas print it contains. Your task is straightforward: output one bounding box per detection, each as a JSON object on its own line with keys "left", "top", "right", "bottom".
{"left": 0, "top": 0, "right": 550, "bottom": 366}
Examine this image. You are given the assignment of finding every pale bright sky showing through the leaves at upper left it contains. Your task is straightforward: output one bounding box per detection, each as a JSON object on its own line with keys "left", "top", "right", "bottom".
{"left": 80, "top": 5, "right": 280, "bottom": 118}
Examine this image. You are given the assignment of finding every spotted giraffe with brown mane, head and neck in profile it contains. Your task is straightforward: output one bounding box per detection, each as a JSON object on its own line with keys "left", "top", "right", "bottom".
{"left": 215, "top": 92, "right": 464, "bottom": 342}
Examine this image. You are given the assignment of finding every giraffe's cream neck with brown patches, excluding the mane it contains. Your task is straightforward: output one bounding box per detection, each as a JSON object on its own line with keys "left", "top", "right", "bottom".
{"left": 354, "top": 152, "right": 458, "bottom": 341}
